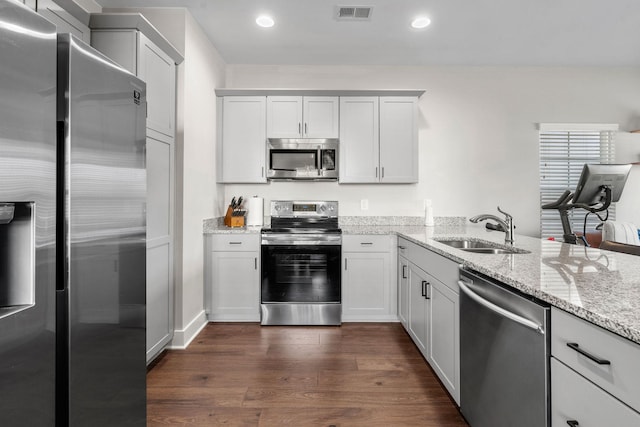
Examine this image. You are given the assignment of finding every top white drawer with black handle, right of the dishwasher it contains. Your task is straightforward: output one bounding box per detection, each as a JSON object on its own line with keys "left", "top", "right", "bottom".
{"left": 551, "top": 308, "right": 640, "bottom": 412}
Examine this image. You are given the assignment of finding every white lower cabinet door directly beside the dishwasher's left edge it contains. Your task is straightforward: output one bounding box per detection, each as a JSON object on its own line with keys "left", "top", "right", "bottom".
{"left": 427, "top": 278, "right": 460, "bottom": 404}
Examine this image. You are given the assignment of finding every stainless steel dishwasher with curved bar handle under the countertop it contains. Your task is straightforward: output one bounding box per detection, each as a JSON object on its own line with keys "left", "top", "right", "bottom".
{"left": 458, "top": 269, "right": 550, "bottom": 427}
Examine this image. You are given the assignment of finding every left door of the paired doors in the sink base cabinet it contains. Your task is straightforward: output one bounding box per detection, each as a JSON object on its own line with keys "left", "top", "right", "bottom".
{"left": 409, "top": 264, "right": 429, "bottom": 357}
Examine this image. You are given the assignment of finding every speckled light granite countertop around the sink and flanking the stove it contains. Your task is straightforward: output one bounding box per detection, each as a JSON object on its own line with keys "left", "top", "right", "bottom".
{"left": 204, "top": 218, "right": 640, "bottom": 344}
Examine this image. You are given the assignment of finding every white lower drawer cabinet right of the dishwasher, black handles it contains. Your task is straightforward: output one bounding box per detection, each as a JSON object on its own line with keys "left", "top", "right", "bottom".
{"left": 551, "top": 307, "right": 640, "bottom": 427}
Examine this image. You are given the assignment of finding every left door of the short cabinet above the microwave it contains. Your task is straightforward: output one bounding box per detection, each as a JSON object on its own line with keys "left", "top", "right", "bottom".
{"left": 267, "top": 96, "right": 303, "bottom": 138}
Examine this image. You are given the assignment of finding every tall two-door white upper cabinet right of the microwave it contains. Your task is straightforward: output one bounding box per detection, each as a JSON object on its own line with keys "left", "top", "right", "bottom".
{"left": 339, "top": 96, "right": 418, "bottom": 183}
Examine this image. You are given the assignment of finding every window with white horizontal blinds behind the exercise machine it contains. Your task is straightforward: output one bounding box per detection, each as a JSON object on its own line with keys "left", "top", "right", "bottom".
{"left": 540, "top": 123, "right": 618, "bottom": 240}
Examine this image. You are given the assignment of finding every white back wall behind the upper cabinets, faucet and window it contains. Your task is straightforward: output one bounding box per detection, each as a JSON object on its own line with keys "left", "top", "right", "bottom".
{"left": 225, "top": 65, "right": 640, "bottom": 236}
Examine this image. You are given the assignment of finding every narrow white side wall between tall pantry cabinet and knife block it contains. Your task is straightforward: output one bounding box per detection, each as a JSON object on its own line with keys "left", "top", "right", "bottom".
{"left": 176, "top": 13, "right": 225, "bottom": 342}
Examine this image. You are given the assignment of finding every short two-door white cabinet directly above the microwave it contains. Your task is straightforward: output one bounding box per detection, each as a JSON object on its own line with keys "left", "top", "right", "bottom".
{"left": 267, "top": 96, "right": 339, "bottom": 138}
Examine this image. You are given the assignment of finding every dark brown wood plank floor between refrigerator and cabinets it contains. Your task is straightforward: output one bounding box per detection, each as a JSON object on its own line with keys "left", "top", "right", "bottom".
{"left": 147, "top": 323, "right": 467, "bottom": 427}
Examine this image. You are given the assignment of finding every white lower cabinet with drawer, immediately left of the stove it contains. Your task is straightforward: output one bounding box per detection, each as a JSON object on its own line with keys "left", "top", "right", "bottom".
{"left": 205, "top": 234, "right": 260, "bottom": 322}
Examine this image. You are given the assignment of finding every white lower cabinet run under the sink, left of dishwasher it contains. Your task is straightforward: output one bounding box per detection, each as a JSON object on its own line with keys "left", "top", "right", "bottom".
{"left": 397, "top": 238, "right": 460, "bottom": 404}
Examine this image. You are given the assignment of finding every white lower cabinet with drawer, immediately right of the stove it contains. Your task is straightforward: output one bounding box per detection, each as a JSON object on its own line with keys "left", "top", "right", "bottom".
{"left": 342, "top": 235, "right": 397, "bottom": 322}
